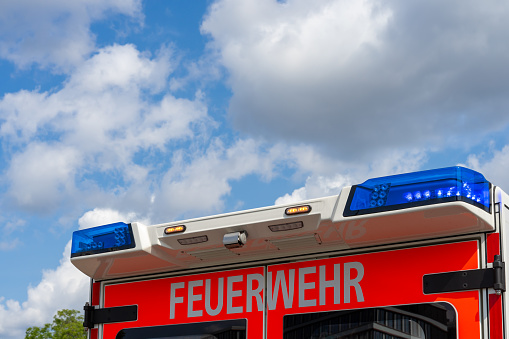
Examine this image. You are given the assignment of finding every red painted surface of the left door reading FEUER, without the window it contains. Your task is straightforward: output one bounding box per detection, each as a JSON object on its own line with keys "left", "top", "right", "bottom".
{"left": 103, "top": 267, "right": 265, "bottom": 338}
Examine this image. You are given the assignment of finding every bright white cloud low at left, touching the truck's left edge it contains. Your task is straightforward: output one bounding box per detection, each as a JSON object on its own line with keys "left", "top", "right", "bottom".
{"left": 0, "top": 242, "right": 90, "bottom": 339}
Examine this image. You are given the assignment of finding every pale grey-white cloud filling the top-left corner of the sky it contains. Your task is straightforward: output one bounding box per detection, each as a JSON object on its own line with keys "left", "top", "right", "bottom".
{"left": 0, "top": 0, "right": 141, "bottom": 71}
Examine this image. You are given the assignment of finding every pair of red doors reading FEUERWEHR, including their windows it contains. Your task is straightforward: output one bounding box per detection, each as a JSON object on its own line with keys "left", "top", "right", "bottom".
{"left": 101, "top": 241, "right": 482, "bottom": 339}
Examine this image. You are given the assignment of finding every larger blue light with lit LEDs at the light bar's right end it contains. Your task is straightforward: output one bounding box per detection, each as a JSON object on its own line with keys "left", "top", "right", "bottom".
{"left": 343, "top": 166, "right": 491, "bottom": 217}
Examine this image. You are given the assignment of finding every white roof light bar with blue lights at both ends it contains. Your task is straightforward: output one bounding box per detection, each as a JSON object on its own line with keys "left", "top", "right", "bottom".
{"left": 71, "top": 168, "right": 495, "bottom": 280}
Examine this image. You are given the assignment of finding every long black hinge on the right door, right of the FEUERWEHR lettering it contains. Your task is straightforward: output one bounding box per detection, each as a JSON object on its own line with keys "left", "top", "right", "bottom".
{"left": 422, "top": 255, "right": 505, "bottom": 294}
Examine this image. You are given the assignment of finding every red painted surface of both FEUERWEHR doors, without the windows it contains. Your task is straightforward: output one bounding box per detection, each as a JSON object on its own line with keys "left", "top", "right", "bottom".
{"left": 98, "top": 241, "right": 480, "bottom": 339}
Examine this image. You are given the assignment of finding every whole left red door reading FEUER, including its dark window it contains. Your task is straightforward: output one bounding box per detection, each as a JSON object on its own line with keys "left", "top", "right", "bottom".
{"left": 102, "top": 267, "right": 265, "bottom": 339}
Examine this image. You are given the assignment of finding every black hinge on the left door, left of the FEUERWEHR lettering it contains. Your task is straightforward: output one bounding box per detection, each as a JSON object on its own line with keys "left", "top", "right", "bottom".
{"left": 83, "top": 303, "right": 138, "bottom": 328}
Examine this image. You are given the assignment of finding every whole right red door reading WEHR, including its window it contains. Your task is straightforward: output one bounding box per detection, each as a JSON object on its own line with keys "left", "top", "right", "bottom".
{"left": 267, "top": 241, "right": 481, "bottom": 339}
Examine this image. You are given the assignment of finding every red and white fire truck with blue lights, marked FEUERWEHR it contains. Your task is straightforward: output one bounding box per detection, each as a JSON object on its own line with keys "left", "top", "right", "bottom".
{"left": 71, "top": 167, "right": 509, "bottom": 339}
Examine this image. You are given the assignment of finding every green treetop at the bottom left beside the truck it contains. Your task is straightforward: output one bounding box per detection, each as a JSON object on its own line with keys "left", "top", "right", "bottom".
{"left": 25, "top": 309, "right": 87, "bottom": 339}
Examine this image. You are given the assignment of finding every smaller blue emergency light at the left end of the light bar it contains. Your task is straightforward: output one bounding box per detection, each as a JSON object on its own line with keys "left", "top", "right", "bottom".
{"left": 71, "top": 222, "right": 135, "bottom": 258}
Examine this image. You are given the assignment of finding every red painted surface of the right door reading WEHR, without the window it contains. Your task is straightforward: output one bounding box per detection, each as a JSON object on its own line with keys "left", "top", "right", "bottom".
{"left": 267, "top": 241, "right": 480, "bottom": 339}
